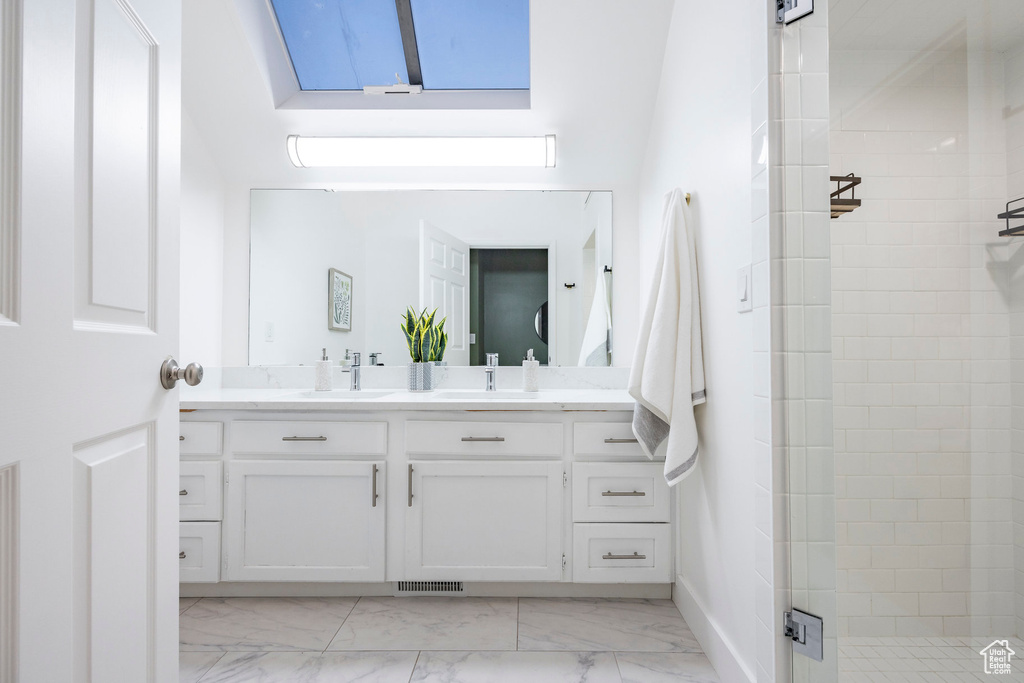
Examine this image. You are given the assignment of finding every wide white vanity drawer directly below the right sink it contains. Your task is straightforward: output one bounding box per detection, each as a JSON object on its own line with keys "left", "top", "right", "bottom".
{"left": 406, "top": 420, "right": 562, "bottom": 456}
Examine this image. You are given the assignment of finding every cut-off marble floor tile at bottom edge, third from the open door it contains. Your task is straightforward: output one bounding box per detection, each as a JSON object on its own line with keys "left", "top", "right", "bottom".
{"left": 411, "top": 651, "right": 621, "bottom": 683}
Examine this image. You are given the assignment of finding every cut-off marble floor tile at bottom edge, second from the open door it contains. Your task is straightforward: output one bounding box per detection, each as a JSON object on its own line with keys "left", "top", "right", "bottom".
{"left": 195, "top": 651, "right": 419, "bottom": 683}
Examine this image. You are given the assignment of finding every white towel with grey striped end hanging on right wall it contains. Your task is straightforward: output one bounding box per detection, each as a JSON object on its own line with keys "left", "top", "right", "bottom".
{"left": 629, "top": 189, "right": 705, "bottom": 486}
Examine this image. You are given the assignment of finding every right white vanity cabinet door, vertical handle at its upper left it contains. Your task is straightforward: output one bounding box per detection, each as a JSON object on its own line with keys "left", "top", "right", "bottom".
{"left": 406, "top": 462, "right": 562, "bottom": 581}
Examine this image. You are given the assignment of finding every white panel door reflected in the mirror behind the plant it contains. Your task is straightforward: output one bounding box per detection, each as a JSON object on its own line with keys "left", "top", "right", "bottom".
{"left": 420, "top": 220, "right": 469, "bottom": 366}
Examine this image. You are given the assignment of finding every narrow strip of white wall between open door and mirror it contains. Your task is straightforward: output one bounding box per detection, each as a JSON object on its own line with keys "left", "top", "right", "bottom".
{"left": 178, "top": 112, "right": 224, "bottom": 368}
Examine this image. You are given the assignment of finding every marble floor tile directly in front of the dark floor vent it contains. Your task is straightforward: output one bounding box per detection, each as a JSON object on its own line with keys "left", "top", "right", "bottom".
{"left": 328, "top": 597, "right": 516, "bottom": 650}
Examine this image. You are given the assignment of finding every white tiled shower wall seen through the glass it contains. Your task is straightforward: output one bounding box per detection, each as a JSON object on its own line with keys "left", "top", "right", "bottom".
{"left": 829, "top": 44, "right": 1024, "bottom": 637}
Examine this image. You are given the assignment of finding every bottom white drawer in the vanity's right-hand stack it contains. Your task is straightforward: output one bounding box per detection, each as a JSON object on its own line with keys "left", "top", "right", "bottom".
{"left": 572, "top": 524, "right": 672, "bottom": 584}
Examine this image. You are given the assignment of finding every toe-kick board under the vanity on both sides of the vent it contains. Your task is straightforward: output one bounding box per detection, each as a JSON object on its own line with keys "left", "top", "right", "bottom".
{"left": 178, "top": 582, "right": 672, "bottom": 600}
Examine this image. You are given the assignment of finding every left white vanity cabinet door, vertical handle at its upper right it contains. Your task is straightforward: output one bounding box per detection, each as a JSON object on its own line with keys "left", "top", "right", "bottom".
{"left": 224, "top": 461, "right": 384, "bottom": 581}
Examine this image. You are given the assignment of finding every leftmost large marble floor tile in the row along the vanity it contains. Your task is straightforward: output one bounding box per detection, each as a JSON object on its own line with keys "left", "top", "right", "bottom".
{"left": 178, "top": 598, "right": 360, "bottom": 651}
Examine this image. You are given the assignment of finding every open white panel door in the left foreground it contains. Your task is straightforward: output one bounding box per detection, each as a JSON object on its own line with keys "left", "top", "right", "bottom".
{"left": 0, "top": 0, "right": 181, "bottom": 683}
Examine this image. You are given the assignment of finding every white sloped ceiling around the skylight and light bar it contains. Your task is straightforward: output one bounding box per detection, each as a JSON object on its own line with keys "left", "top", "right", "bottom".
{"left": 182, "top": 0, "right": 679, "bottom": 188}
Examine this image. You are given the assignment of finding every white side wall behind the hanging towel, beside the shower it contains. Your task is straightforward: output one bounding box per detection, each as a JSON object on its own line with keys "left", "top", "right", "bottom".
{"left": 639, "top": 2, "right": 764, "bottom": 681}
